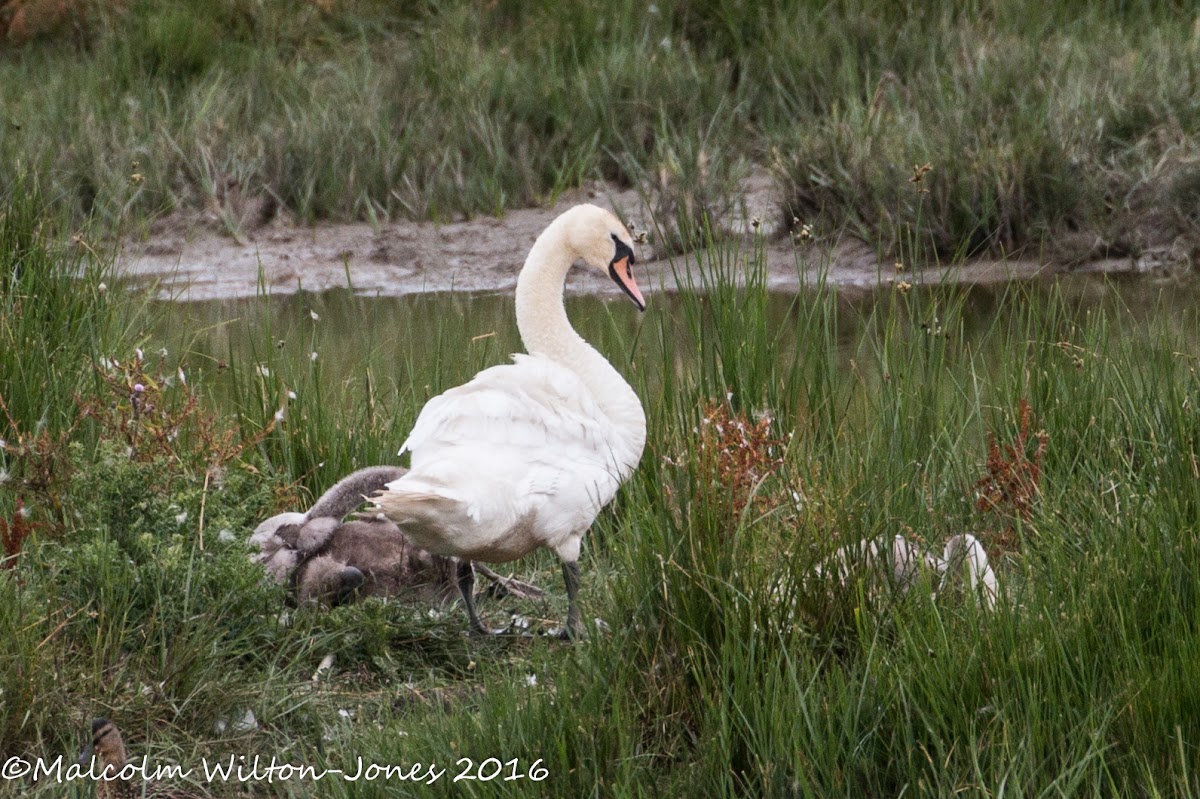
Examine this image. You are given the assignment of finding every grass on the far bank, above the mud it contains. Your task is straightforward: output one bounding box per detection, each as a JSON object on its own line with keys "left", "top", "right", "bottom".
{"left": 0, "top": 0, "right": 1200, "bottom": 263}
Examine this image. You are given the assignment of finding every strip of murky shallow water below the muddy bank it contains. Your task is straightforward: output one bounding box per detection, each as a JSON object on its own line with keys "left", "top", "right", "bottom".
{"left": 166, "top": 268, "right": 1200, "bottom": 393}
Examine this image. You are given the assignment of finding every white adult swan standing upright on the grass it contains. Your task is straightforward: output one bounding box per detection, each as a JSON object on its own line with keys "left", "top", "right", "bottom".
{"left": 372, "top": 205, "right": 646, "bottom": 636}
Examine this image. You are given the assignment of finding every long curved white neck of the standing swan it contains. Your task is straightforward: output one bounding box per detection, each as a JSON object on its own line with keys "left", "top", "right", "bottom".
{"left": 516, "top": 217, "right": 646, "bottom": 465}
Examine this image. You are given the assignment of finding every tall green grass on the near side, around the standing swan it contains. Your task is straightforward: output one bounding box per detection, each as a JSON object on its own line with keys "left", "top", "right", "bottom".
{"left": 0, "top": 177, "right": 1200, "bottom": 797}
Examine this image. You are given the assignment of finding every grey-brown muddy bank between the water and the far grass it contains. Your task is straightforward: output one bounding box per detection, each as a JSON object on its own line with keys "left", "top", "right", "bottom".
{"left": 120, "top": 175, "right": 1142, "bottom": 301}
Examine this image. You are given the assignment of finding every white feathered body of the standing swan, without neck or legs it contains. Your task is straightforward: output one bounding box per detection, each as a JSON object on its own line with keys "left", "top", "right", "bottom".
{"left": 380, "top": 355, "right": 641, "bottom": 557}
